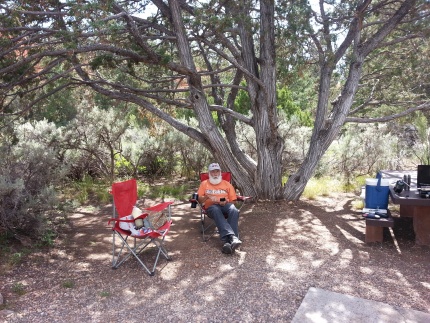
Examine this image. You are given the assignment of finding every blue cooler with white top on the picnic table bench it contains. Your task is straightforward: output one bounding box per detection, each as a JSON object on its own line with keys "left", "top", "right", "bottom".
{"left": 364, "top": 177, "right": 390, "bottom": 209}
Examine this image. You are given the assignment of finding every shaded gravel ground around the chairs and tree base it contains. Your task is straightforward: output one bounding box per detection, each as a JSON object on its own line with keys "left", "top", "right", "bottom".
{"left": 0, "top": 194, "right": 430, "bottom": 322}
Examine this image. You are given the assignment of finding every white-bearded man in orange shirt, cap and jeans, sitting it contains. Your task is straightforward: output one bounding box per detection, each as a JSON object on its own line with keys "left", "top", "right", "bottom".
{"left": 197, "top": 163, "right": 242, "bottom": 254}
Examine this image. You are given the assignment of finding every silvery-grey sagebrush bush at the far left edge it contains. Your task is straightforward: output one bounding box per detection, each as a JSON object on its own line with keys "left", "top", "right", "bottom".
{"left": 0, "top": 116, "right": 63, "bottom": 237}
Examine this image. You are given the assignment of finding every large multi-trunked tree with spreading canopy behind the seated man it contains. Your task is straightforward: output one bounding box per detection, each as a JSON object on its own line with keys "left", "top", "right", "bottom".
{"left": 0, "top": 0, "right": 430, "bottom": 200}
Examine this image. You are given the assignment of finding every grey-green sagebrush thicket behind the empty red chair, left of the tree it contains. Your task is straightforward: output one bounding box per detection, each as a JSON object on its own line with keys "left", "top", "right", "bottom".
{"left": 0, "top": 104, "right": 207, "bottom": 247}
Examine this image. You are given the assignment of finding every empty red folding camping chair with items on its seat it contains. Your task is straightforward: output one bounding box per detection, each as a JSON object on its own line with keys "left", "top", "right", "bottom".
{"left": 108, "top": 179, "right": 173, "bottom": 276}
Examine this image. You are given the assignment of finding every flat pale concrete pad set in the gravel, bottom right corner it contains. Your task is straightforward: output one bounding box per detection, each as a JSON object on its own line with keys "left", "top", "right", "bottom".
{"left": 292, "top": 287, "right": 430, "bottom": 323}
